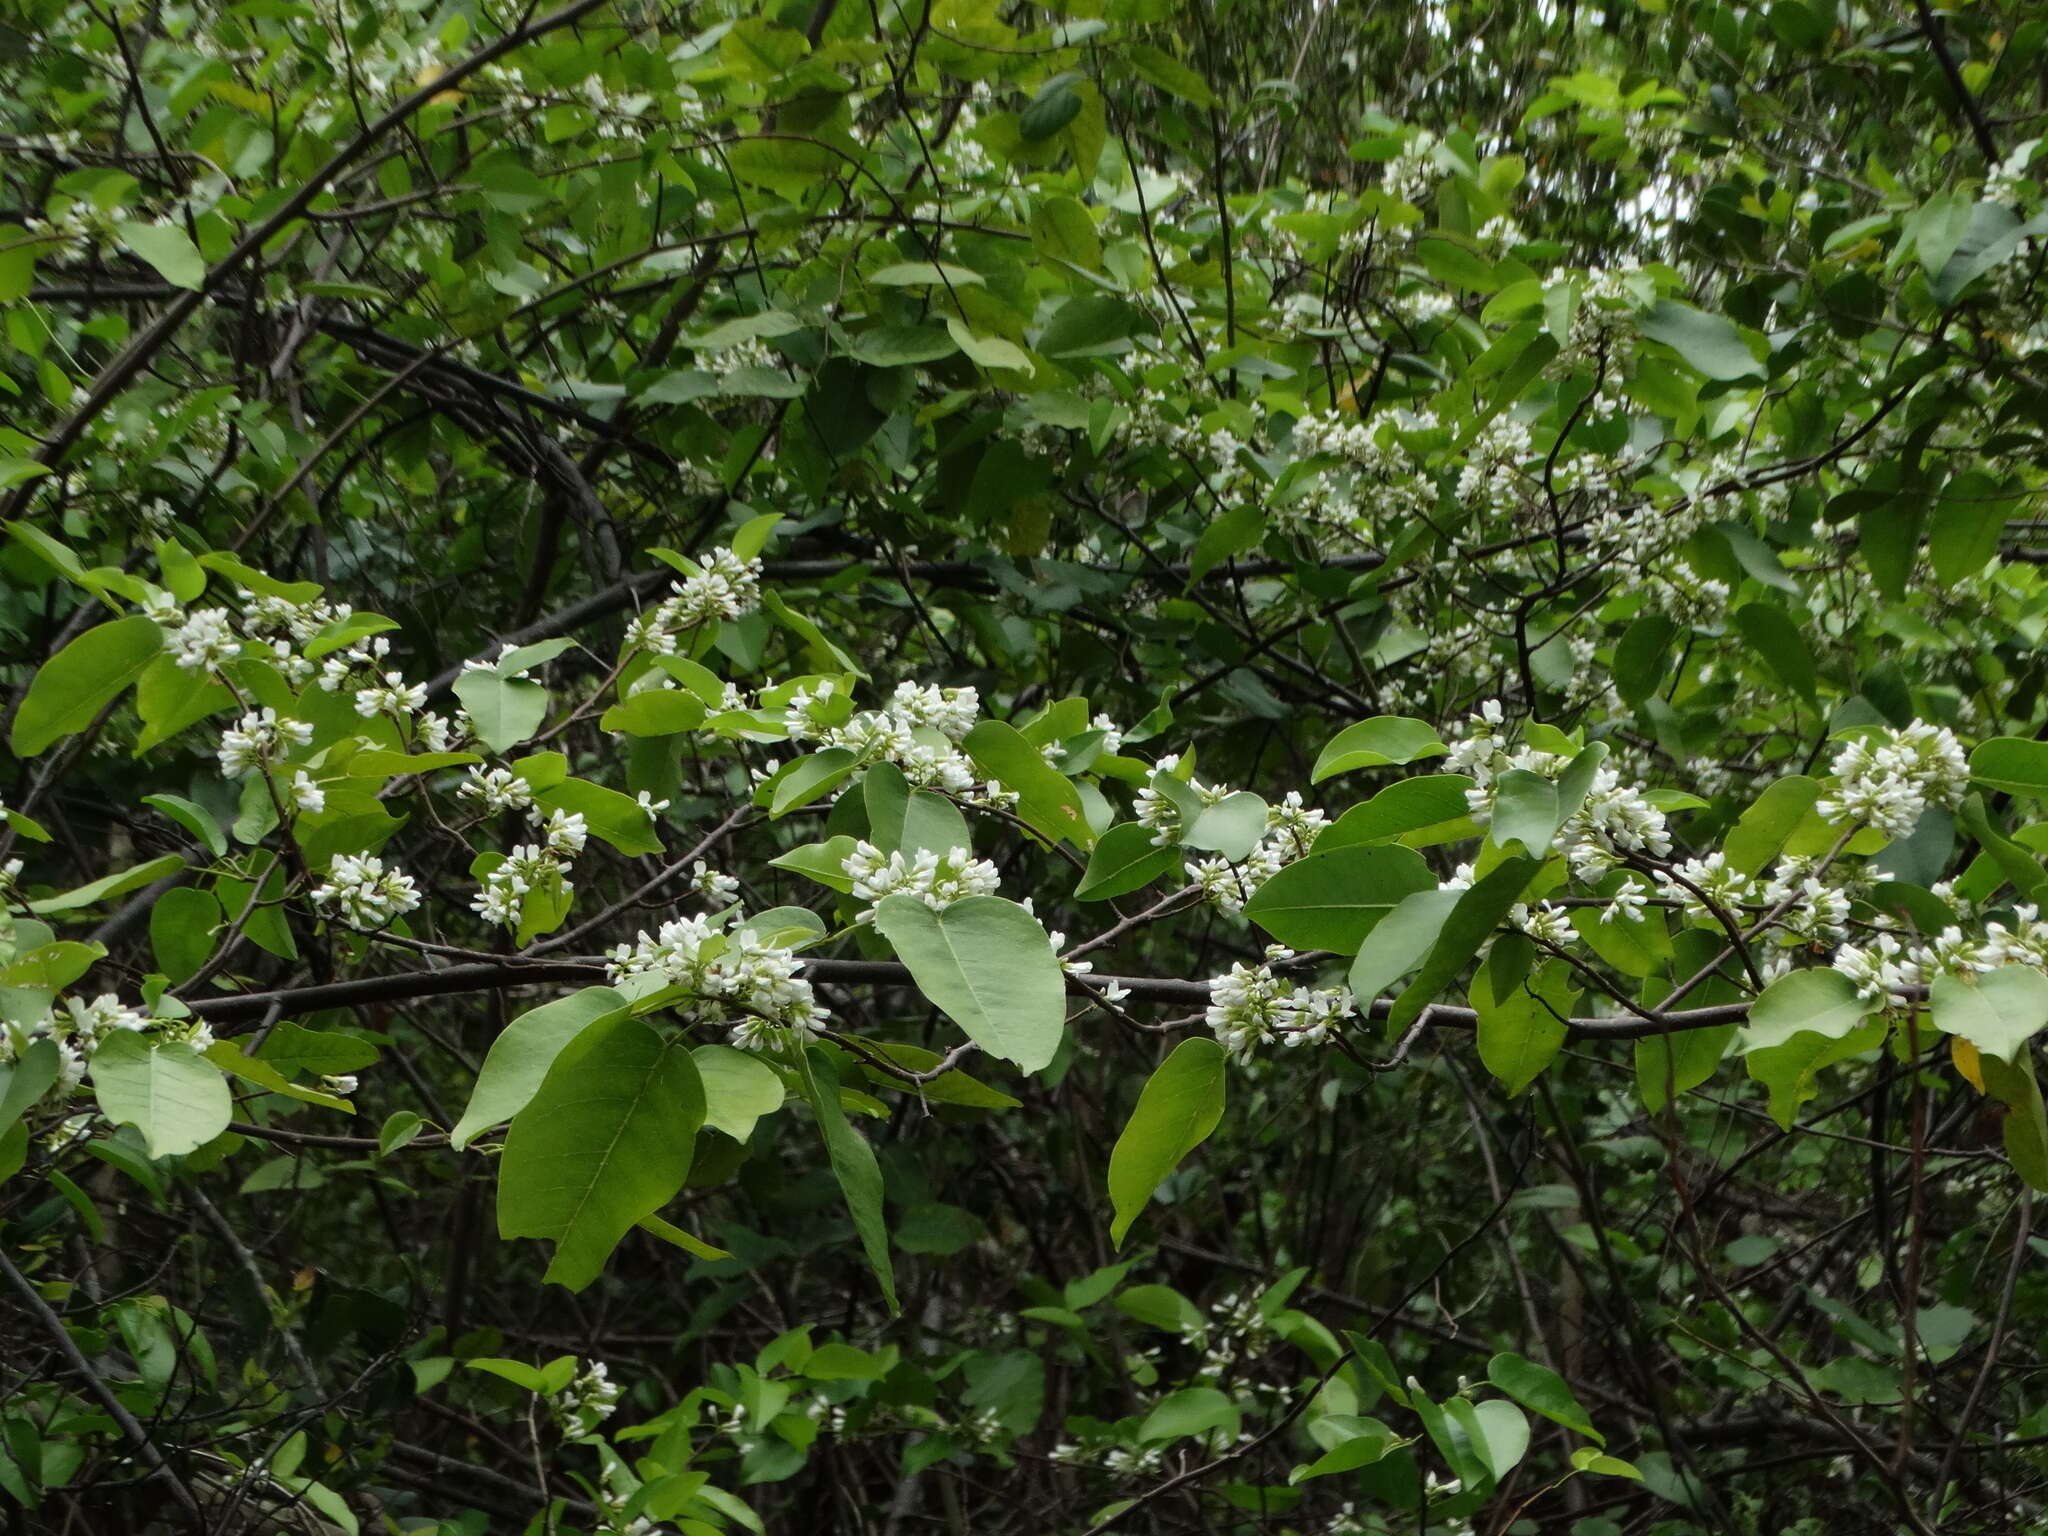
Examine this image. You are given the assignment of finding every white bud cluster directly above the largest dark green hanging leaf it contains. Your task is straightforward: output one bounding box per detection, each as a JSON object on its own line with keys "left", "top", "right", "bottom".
{"left": 606, "top": 909, "right": 827, "bottom": 1051}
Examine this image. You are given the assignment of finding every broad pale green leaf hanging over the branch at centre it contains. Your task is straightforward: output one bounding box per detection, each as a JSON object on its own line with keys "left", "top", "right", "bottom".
{"left": 874, "top": 895, "right": 1067, "bottom": 1071}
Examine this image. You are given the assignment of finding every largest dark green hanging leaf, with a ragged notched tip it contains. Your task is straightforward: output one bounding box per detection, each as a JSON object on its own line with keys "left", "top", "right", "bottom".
{"left": 498, "top": 1018, "right": 705, "bottom": 1290}
